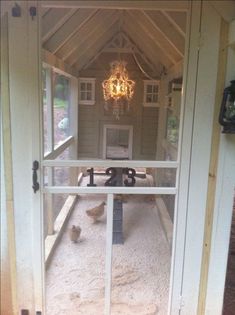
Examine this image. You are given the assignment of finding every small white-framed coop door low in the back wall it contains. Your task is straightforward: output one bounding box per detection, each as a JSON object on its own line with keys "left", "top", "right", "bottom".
{"left": 103, "top": 125, "right": 133, "bottom": 159}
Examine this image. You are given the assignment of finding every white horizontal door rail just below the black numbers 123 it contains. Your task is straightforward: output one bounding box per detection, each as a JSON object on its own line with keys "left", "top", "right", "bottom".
{"left": 43, "top": 186, "right": 177, "bottom": 195}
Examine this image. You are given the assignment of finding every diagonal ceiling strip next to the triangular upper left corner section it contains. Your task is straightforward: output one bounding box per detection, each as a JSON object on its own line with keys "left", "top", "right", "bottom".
{"left": 44, "top": 9, "right": 98, "bottom": 53}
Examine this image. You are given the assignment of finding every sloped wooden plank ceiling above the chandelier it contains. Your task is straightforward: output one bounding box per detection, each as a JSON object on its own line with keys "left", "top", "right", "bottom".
{"left": 42, "top": 1, "right": 187, "bottom": 73}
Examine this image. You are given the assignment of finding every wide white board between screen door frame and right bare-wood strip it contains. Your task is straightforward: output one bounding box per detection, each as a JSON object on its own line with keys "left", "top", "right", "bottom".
{"left": 179, "top": 2, "right": 221, "bottom": 315}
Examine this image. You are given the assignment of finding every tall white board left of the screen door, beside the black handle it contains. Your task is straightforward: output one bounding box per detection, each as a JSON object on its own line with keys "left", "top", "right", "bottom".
{"left": 1, "top": 1, "right": 43, "bottom": 315}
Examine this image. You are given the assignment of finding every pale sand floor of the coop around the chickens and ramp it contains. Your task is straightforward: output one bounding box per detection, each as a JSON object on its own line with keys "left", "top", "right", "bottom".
{"left": 46, "top": 176, "right": 171, "bottom": 315}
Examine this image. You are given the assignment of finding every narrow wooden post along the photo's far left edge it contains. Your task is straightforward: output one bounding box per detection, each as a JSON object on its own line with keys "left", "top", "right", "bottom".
{"left": 1, "top": 13, "right": 18, "bottom": 315}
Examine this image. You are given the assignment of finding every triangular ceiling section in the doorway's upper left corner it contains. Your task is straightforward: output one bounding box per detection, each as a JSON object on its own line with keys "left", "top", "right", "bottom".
{"left": 42, "top": 9, "right": 76, "bottom": 43}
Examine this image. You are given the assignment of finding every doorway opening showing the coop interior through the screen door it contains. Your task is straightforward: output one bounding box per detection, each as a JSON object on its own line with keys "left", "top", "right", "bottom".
{"left": 42, "top": 3, "right": 187, "bottom": 315}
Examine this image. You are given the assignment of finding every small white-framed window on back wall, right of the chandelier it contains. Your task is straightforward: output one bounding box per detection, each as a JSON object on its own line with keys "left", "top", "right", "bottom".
{"left": 144, "top": 80, "right": 159, "bottom": 107}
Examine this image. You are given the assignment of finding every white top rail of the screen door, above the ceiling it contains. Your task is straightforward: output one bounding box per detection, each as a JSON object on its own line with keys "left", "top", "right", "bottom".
{"left": 41, "top": 0, "right": 190, "bottom": 12}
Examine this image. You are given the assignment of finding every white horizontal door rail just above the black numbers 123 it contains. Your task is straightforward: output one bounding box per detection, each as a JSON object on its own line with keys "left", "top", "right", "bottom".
{"left": 42, "top": 159, "right": 179, "bottom": 168}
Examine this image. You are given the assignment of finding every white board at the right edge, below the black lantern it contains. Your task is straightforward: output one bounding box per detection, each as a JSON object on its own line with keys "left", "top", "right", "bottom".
{"left": 205, "top": 135, "right": 235, "bottom": 315}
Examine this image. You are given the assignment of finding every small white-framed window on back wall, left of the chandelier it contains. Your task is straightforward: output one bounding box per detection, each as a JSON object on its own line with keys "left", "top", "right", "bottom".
{"left": 79, "top": 78, "right": 95, "bottom": 105}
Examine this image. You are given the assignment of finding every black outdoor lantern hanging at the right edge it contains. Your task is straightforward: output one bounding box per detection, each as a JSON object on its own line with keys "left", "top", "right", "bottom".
{"left": 219, "top": 80, "right": 235, "bottom": 134}
